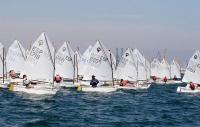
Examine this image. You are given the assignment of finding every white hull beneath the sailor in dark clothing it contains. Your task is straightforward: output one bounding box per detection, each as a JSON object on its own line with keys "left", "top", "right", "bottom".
{"left": 81, "top": 87, "right": 117, "bottom": 93}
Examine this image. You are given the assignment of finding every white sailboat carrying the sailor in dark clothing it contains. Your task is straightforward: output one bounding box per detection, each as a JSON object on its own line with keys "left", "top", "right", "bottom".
{"left": 77, "top": 41, "right": 117, "bottom": 92}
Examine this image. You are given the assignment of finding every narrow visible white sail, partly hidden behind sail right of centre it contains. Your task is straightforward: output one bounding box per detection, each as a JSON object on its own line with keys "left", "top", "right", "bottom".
{"left": 133, "top": 49, "right": 147, "bottom": 80}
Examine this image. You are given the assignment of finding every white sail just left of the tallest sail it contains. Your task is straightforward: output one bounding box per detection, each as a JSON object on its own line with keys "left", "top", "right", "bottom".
{"left": 6, "top": 40, "right": 26, "bottom": 73}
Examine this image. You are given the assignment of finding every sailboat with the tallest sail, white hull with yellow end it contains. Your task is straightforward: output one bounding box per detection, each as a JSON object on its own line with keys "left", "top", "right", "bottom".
{"left": 9, "top": 33, "right": 58, "bottom": 94}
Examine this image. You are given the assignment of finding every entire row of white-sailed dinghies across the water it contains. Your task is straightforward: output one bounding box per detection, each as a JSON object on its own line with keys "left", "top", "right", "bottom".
{"left": 0, "top": 33, "right": 200, "bottom": 94}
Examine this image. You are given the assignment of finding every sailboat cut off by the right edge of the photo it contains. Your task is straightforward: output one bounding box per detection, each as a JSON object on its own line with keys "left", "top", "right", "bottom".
{"left": 177, "top": 50, "right": 200, "bottom": 93}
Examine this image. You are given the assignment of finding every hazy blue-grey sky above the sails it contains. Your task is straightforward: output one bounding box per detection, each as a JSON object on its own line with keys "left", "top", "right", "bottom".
{"left": 0, "top": 0, "right": 200, "bottom": 64}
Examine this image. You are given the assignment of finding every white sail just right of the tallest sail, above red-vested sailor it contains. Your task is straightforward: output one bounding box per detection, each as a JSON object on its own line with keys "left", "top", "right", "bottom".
{"left": 55, "top": 42, "right": 74, "bottom": 79}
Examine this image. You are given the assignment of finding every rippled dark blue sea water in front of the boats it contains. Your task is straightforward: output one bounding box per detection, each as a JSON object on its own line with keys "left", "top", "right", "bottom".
{"left": 0, "top": 84, "right": 200, "bottom": 127}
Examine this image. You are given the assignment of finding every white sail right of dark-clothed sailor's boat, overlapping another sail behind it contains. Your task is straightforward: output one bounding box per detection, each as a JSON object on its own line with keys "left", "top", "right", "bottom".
{"left": 115, "top": 48, "right": 137, "bottom": 81}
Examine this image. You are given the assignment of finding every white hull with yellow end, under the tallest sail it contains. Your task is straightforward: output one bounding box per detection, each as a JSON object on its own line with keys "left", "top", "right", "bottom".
{"left": 10, "top": 85, "right": 58, "bottom": 95}
